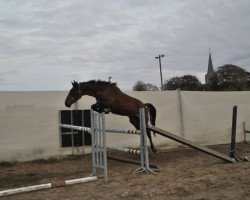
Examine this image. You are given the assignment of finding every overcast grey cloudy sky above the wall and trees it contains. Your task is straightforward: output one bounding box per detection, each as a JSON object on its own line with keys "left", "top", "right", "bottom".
{"left": 0, "top": 0, "right": 250, "bottom": 91}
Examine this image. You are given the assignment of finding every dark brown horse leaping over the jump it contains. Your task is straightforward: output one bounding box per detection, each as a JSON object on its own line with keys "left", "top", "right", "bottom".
{"left": 65, "top": 80, "right": 157, "bottom": 153}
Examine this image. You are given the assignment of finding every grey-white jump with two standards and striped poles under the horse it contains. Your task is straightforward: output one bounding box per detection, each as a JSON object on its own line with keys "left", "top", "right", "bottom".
{"left": 59, "top": 108, "right": 156, "bottom": 182}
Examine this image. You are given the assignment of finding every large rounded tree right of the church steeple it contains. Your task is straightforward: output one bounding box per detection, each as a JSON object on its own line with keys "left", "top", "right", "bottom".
{"left": 208, "top": 64, "right": 250, "bottom": 90}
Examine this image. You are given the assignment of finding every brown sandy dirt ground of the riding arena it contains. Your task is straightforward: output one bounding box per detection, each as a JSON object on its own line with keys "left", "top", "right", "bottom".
{"left": 0, "top": 144, "right": 250, "bottom": 200}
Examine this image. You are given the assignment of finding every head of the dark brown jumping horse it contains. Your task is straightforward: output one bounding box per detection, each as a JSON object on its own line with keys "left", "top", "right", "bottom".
{"left": 65, "top": 81, "right": 82, "bottom": 108}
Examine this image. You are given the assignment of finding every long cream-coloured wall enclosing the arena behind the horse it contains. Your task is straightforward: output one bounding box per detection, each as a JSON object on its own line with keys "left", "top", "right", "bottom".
{"left": 0, "top": 91, "right": 250, "bottom": 161}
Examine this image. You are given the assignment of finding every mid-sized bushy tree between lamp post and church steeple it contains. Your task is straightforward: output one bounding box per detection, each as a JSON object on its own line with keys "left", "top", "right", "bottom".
{"left": 163, "top": 75, "right": 202, "bottom": 91}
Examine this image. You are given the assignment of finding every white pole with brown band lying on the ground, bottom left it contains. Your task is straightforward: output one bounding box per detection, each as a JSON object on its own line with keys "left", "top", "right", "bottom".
{"left": 0, "top": 176, "right": 97, "bottom": 197}
